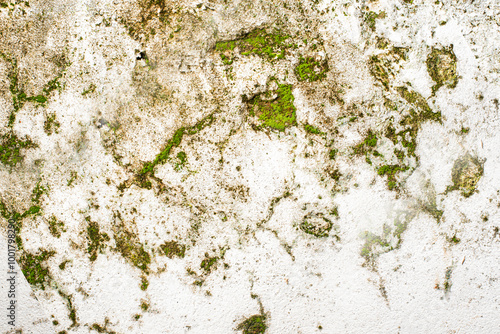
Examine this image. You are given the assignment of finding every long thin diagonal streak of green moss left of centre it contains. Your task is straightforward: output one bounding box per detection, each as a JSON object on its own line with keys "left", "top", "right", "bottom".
{"left": 139, "top": 113, "right": 215, "bottom": 175}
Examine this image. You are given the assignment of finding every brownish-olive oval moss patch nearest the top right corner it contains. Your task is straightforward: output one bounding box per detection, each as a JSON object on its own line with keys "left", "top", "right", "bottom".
{"left": 426, "top": 45, "right": 458, "bottom": 93}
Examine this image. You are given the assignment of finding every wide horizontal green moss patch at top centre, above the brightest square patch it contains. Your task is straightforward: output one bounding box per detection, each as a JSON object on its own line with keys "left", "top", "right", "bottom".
{"left": 215, "top": 29, "right": 292, "bottom": 62}
